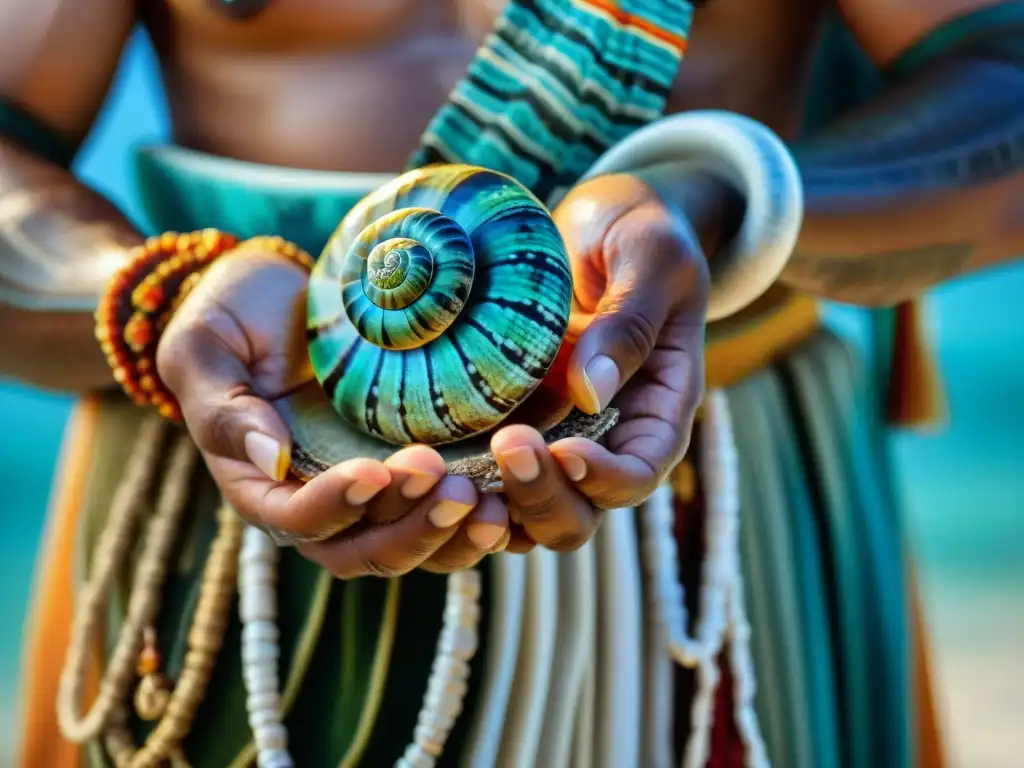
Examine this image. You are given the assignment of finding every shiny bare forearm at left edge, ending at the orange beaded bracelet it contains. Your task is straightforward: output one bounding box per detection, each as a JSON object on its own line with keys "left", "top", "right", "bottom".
{"left": 0, "top": 138, "right": 141, "bottom": 391}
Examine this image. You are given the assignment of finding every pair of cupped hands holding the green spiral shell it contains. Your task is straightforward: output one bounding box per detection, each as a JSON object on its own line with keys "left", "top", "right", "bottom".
{"left": 158, "top": 175, "right": 709, "bottom": 579}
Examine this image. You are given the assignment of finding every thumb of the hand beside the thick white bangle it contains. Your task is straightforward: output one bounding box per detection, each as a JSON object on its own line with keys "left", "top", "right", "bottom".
{"left": 568, "top": 270, "right": 671, "bottom": 414}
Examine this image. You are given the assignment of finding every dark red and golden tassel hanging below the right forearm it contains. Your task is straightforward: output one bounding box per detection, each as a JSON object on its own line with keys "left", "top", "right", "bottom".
{"left": 887, "top": 299, "right": 947, "bottom": 431}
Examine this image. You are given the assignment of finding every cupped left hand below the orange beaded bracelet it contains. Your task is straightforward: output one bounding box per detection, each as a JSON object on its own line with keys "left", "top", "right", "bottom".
{"left": 157, "top": 249, "right": 509, "bottom": 578}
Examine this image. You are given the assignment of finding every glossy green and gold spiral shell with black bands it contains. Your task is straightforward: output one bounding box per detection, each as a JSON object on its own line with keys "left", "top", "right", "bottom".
{"left": 307, "top": 165, "right": 572, "bottom": 444}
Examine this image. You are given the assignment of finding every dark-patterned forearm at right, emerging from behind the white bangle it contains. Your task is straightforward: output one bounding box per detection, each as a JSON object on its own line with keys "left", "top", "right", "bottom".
{"left": 782, "top": 8, "right": 1024, "bottom": 305}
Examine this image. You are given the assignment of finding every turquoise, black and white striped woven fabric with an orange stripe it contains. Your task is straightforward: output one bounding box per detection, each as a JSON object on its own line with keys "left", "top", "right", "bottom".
{"left": 410, "top": 0, "right": 693, "bottom": 200}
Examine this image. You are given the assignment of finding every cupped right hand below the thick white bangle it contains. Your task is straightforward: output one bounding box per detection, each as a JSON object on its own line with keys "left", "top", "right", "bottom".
{"left": 492, "top": 175, "right": 709, "bottom": 552}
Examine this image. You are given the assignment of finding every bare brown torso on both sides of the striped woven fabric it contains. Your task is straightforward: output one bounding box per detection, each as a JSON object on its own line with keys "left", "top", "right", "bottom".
{"left": 145, "top": 0, "right": 824, "bottom": 172}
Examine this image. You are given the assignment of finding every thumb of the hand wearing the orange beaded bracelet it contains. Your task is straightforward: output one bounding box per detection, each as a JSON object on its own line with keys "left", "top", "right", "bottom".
{"left": 157, "top": 310, "right": 291, "bottom": 480}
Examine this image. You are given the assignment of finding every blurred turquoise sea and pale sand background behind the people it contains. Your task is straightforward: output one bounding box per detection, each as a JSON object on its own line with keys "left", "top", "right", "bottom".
{"left": 0, "top": 28, "right": 1024, "bottom": 768}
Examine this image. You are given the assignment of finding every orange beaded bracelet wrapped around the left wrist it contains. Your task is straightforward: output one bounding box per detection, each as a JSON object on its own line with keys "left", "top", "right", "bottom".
{"left": 95, "top": 229, "right": 313, "bottom": 421}
